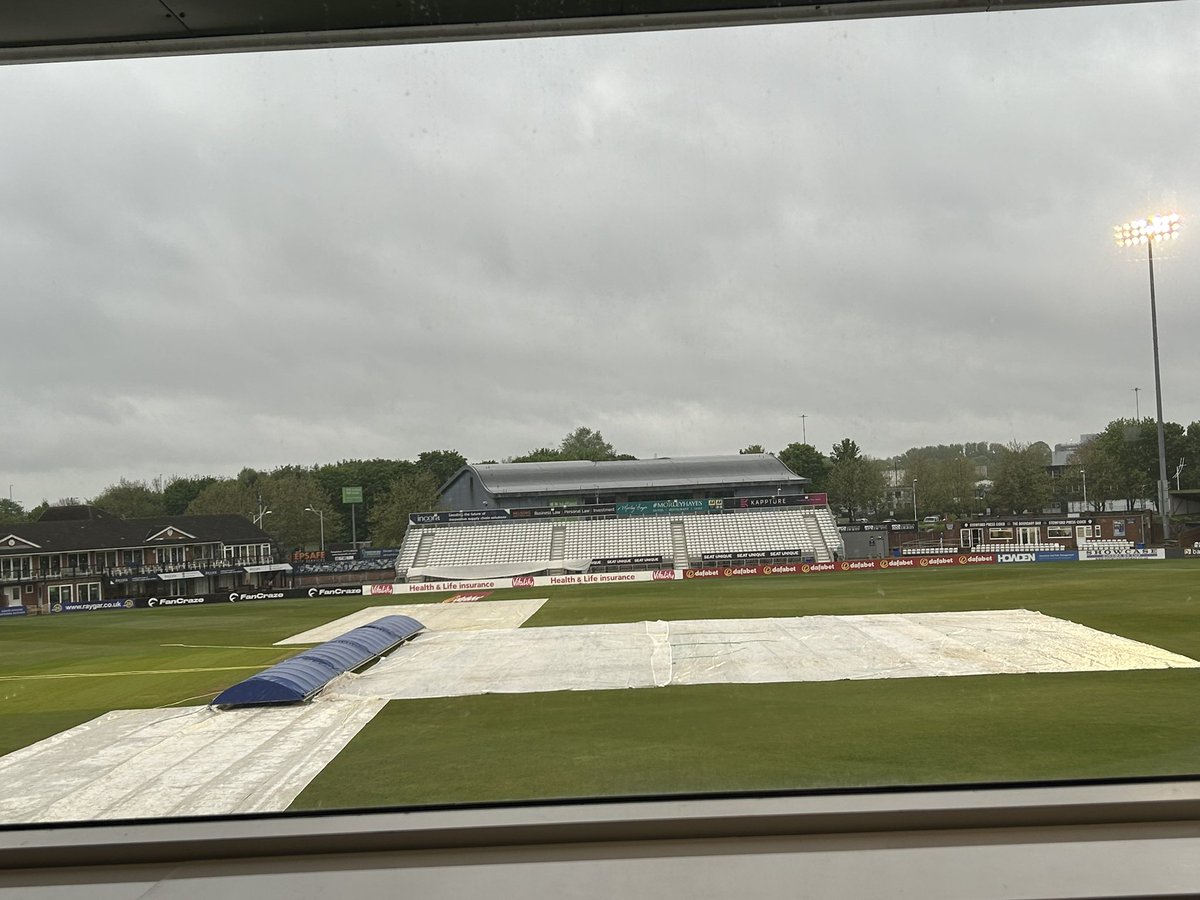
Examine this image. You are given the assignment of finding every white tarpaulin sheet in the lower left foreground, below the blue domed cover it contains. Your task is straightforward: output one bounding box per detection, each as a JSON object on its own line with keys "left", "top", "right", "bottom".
{"left": 0, "top": 698, "right": 385, "bottom": 823}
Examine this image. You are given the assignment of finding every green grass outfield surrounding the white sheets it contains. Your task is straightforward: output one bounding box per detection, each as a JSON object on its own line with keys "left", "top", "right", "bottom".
{"left": 0, "top": 560, "right": 1200, "bottom": 809}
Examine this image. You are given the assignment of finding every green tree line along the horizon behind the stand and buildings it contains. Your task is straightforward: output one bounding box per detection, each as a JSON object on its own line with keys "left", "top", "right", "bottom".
{"left": 0, "top": 419, "right": 1200, "bottom": 550}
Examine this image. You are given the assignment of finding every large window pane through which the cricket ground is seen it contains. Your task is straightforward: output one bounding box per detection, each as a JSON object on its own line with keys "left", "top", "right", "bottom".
{"left": 0, "top": 4, "right": 1200, "bottom": 823}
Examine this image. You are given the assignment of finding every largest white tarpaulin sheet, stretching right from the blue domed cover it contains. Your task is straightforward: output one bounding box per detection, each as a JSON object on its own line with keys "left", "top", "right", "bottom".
{"left": 335, "top": 610, "right": 1200, "bottom": 700}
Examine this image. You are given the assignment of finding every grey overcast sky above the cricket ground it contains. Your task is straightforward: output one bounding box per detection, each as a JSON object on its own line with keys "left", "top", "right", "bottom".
{"left": 0, "top": 0, "right": 1200, "bottom": 506}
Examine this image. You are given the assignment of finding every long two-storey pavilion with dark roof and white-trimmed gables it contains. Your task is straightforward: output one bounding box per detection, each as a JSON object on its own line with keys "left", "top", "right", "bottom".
{"left": 0, "top": 506, "right": 283, "bottom": 612}
